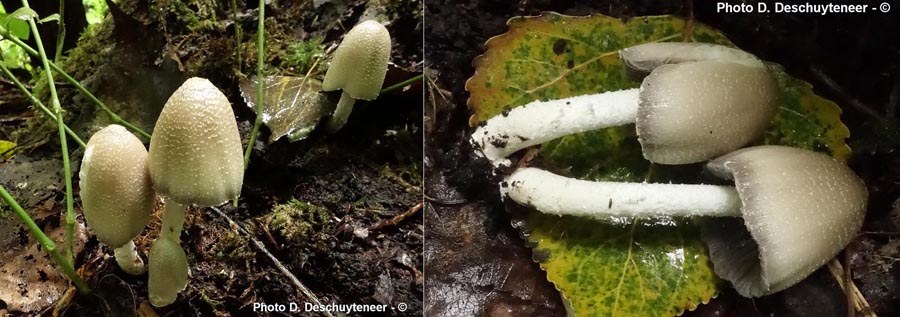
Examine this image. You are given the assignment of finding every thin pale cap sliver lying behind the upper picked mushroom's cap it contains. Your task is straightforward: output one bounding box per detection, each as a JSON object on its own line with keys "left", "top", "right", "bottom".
{"left": 619, "top": 42, "right": 764, "bottom": 73}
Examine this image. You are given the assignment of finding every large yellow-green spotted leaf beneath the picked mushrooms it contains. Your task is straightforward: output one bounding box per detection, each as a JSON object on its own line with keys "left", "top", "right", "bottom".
{"left": 466, "top": 13, "right": 850, "bottom": 317}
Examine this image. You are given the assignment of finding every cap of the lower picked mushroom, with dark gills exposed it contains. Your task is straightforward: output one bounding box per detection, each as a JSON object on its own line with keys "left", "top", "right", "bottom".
{"left": 704, "top": 146, "right": 868, "bottom": 297}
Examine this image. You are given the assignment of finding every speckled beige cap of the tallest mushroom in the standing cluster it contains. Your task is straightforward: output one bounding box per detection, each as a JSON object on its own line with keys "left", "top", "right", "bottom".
{"left": 150, "top": 77, "right": 244, "bottom": 206}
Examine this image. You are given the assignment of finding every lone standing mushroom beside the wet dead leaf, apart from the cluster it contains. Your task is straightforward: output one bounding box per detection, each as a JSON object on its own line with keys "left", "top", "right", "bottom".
{"left": 322, "top": 20, "right": 391, "bottom": 133}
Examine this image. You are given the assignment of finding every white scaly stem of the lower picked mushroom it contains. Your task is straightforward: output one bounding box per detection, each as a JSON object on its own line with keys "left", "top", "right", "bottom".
{"left": 501, "top": 167, "right": 741, "bottom": 219}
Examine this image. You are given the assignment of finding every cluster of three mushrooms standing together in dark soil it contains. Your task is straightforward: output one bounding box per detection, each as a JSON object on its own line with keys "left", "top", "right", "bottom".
{"left": 79, "top": 77, "right": 244, "bottom": 306}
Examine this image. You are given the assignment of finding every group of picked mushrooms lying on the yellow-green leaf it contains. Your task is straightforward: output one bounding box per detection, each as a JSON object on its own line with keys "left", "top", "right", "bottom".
{"left": 471, "top": 43, "right": 868, "bottom": 297}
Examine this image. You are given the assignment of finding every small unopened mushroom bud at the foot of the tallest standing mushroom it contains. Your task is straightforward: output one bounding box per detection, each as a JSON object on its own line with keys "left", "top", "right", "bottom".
{"left": 147, "top": 239, "right": 188, "bottom": 307}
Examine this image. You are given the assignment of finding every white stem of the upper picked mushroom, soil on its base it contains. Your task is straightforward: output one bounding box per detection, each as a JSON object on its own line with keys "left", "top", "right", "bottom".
{"left": 472, "top": 88, "right": 639, "bottom": 166}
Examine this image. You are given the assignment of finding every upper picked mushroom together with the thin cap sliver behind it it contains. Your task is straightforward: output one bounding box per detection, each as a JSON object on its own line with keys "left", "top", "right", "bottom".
{"left": 471, "top": 43, "right": 777, "bottom": 166}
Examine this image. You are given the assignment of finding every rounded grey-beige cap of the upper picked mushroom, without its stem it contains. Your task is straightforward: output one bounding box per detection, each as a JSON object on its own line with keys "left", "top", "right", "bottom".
{"left": 635, "top": 61, "right": 777, "bottom": 164}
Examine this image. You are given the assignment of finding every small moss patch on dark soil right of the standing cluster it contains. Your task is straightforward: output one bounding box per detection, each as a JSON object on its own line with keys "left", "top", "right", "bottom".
{"left": 264, "top": 199, "right": 334, "bottom": 246}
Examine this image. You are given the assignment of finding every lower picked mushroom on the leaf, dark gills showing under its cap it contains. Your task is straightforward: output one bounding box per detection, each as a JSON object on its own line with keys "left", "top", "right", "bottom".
{"left": 502, "top": 145, "right": 868, "bottom": 297}
